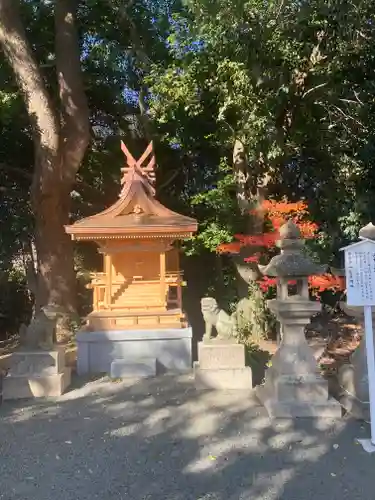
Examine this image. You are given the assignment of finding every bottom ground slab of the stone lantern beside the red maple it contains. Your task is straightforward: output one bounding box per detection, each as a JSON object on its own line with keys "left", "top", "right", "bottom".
{"left": 256, "top": 386, "right": 342, "bottom": 419}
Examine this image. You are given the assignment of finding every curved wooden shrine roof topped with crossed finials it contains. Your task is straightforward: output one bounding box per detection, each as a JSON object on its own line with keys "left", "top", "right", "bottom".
{"left": 65, "top": 142, "right": 198, "bottom": 240}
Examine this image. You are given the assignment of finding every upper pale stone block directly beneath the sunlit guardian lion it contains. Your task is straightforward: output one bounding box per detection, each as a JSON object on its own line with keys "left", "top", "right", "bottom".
{"left": 198, "top": 339, "right": 245, "bottom": 369}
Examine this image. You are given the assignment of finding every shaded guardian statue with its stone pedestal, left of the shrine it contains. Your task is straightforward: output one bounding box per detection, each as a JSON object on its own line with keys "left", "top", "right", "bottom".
{"left": 3, "top": 306, "right": 70, "bottom": 400}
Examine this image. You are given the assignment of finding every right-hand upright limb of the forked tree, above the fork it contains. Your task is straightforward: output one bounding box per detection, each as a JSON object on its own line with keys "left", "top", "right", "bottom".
{"left": 55, "top": 0, "right": 90, "bottom": 183}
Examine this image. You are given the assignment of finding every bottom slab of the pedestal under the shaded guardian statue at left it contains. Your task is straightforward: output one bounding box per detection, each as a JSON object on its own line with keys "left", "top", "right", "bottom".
{"left": 3, "top": 368, "right": 71, "bottom": 400}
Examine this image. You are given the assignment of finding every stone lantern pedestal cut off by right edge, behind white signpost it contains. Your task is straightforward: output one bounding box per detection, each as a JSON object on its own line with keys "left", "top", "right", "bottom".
{"left": 338, "top": 302, "right": 375, "bottom": 420}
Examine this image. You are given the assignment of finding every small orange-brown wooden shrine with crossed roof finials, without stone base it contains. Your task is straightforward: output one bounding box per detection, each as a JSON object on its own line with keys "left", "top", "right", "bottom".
{"left": 65, "top": 142, "right": 197, "bottom": 331}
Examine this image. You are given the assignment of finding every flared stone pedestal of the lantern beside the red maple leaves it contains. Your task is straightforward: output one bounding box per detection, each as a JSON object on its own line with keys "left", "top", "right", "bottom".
{"left": 256, "top": 296, "right": 341, "bottom": 418}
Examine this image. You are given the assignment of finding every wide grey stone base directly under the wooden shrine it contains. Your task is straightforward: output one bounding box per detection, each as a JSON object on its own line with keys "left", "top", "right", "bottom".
{"left": 77, "top": 328, "right": 192, "bottom": 375}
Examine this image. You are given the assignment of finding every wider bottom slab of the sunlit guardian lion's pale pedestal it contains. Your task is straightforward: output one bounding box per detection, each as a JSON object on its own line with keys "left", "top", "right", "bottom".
{"left": 194, "top": 362, "right": 253, "bottom": 391}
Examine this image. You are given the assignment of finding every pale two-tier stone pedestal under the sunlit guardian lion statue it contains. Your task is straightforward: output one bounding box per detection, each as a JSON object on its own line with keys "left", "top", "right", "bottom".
{"left": 194, "top": 339, "right": 252, "bottom": 390}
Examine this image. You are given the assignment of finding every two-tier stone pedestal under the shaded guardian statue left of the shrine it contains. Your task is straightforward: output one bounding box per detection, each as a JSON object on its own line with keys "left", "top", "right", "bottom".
{"left": 3, "top": 346, "right": 70, "bottom": 400}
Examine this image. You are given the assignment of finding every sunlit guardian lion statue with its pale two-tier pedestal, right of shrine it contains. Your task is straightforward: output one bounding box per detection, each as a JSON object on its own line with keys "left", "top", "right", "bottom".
{"left": 194, "top": 297, "right": 252, "bottom": 390}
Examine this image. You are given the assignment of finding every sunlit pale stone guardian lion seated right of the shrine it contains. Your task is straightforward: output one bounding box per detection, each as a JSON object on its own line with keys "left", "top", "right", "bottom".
{"left": 201, "top": 297, "right": 236, "bottom": 340}
